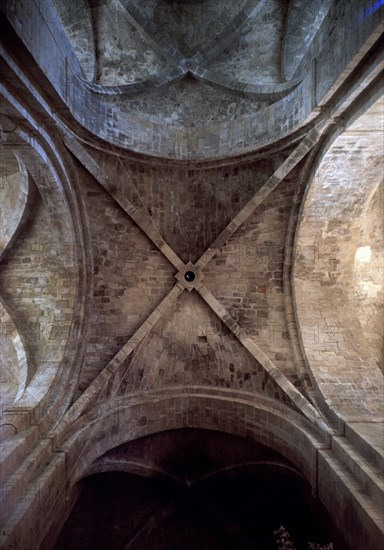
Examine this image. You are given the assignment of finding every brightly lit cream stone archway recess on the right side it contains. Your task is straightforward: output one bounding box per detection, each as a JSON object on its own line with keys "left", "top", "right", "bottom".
{"left": 293, "top": 97, "right": 384, "bottom": 422}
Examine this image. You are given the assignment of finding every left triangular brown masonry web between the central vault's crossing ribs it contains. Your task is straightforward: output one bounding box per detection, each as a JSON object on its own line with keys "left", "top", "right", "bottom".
{"left": 74, "top": 168, "right": 175, "bottom": 391}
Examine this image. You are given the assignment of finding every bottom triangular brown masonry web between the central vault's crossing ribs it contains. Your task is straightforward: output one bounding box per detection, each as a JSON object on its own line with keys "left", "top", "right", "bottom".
{"left": 118, "top": 293, "right": 284, "bottom": 400}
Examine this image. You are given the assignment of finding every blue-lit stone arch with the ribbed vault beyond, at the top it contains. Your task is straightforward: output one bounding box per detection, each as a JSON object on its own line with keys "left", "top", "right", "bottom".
{"left": 15, "top": 0, "right": 354, "bottom": 159}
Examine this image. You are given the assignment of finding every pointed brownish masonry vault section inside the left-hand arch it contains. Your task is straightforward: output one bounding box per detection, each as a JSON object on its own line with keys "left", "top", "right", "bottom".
{"left": 0, "top": 183, "right": 75, "bottom": 390}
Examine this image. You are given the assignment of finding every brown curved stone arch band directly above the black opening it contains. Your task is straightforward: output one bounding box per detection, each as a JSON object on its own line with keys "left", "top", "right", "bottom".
{"left": 54, "top": 388, "right": 328, "bottom": 485}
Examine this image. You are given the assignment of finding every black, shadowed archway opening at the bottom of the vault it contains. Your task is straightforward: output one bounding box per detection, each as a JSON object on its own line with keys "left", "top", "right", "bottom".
{"left": 54, "top": 428, "right": 348, "bottom": 550}
